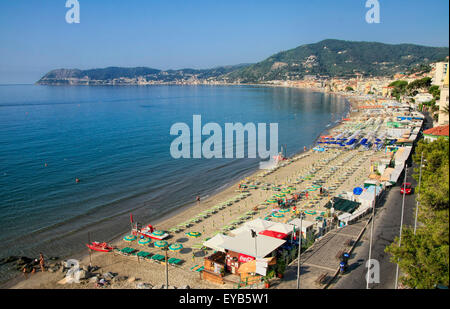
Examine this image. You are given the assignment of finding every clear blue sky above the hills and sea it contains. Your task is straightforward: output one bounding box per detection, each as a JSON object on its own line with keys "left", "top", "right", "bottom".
{"left": 0, "top": 0, "right": 449, "bottom": 83}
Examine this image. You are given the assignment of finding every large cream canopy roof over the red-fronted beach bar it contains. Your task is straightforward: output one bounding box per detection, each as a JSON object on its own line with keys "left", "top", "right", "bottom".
{"left": 220, "top": 232, "right": 286, "bottom": 258}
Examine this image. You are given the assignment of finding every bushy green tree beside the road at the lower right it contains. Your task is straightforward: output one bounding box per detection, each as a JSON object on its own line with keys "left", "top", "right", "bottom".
{"left": 386, "top": 138, "right": 449, "bottom": 289}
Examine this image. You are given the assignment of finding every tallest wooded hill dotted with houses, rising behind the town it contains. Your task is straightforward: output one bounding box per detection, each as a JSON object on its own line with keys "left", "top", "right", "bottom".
{"left": 226, "top": 40, "right": 449, "bottom": 83}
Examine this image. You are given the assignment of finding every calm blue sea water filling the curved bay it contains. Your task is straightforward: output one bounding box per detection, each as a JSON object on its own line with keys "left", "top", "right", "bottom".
{"left": 0, "top": 85, "right": 347, "bottom": 257}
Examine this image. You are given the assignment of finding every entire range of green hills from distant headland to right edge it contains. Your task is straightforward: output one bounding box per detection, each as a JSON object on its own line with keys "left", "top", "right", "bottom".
{"left": 37, "top": 40, "right": 449, "bottom": 85}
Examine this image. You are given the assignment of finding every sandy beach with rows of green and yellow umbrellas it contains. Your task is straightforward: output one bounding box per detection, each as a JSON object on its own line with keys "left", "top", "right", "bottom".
{"left": 6, "top": 89, "right": 375, "bottom": 289}
